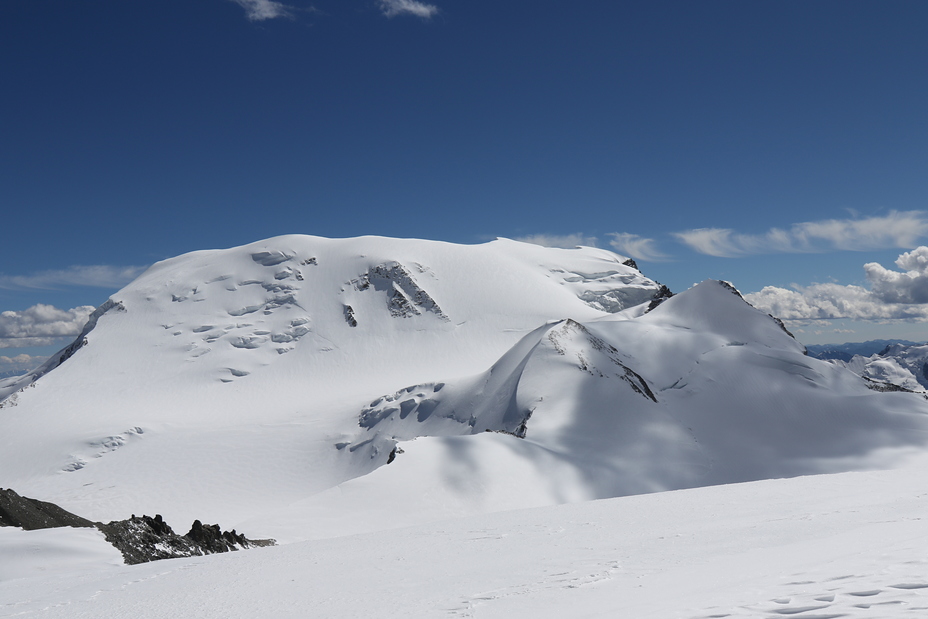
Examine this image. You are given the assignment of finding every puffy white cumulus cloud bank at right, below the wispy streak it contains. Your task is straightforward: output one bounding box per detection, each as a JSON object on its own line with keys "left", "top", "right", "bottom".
{"left": 744, "top": 246, "right": 928, "bottom": 322}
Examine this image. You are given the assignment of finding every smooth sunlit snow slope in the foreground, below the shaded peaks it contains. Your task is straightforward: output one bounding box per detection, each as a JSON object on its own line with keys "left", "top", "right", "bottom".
{"left": 0, "top": 452, "right": 928, "bottom": 619}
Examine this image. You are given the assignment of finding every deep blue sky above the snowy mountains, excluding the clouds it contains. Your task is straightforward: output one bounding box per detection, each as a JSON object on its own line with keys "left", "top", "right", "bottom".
{"left": 0, "top": 0, "right": 928, "bottom": 354}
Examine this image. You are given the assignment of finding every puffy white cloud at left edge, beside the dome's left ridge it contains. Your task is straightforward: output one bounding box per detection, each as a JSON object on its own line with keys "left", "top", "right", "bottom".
{"left": 0, "top": 303, "right": 94, "bottom": 348}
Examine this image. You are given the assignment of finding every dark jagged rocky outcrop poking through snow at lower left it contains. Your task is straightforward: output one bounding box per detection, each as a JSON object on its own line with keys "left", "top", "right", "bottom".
{"left": 0, "top": 488, "right": 275, "bottom": 565}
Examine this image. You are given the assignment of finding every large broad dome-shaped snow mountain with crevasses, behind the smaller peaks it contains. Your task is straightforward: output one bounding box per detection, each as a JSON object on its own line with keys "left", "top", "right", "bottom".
{"left": 0, "top": 236, "right": 659, "bottom": 526}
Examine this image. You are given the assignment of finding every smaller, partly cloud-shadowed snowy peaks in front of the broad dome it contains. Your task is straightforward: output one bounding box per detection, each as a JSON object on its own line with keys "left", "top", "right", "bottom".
{"left": 249, "top": 281, "right": 928, "bottom": 539}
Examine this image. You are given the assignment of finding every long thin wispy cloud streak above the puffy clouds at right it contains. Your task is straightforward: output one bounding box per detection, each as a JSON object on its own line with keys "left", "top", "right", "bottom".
{"left": 673, "top": 211, "right": 928, "bottom": 258}
